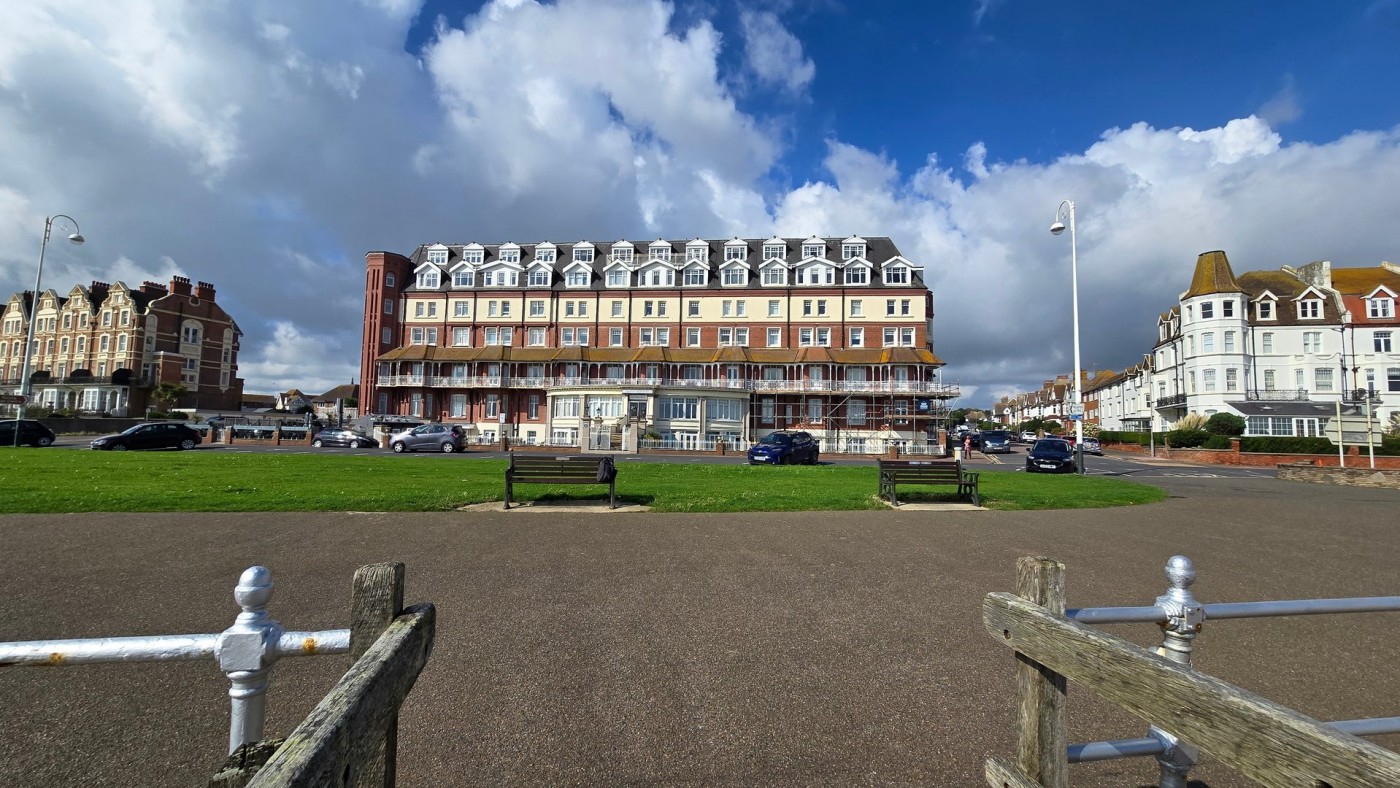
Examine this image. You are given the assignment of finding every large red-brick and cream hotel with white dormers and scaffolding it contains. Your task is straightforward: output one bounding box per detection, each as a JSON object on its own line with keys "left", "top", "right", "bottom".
{"left": 360, "top": 237, "right": 958, "bottom": 452}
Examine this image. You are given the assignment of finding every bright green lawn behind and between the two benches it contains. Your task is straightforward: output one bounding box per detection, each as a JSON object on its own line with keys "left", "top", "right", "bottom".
{"left": 0, "top": 448, "right": 1166, "bottom": 514}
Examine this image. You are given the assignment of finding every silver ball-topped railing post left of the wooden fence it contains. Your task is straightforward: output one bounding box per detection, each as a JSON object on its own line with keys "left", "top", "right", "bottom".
{"left": 214, "top": 567, "right": 281, "bottom": 753}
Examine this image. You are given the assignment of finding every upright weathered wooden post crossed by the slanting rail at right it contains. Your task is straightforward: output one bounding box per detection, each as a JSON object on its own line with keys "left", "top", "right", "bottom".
{"left": 1016, "top": 556, "right": 1070, "bottom": 788}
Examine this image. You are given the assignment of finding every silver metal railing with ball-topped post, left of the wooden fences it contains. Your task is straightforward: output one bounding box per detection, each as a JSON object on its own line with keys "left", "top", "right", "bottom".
{"left": 0, "top": 567, "right": 350, "bottom": 753}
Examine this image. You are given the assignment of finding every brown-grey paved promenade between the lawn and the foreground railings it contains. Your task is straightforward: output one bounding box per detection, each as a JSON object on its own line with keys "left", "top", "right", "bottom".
{"left": 0, "top": 479, "right": 1400, "bottom": 788}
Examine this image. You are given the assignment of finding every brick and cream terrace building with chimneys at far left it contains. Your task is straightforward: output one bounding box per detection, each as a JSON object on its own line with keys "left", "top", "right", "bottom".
{"left": 0, "top": 276, "right": 244, "bottom": 416}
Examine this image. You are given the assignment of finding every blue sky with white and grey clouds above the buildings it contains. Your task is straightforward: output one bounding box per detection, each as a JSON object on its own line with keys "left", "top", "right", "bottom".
{"left": 8, "top": 0, "right": 1400, "bottom": 404}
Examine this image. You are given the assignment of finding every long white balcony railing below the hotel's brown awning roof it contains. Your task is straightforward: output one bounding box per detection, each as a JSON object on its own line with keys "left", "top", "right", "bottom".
{"left": 378, "top": 375, "right": 957, "bottom": 402}
